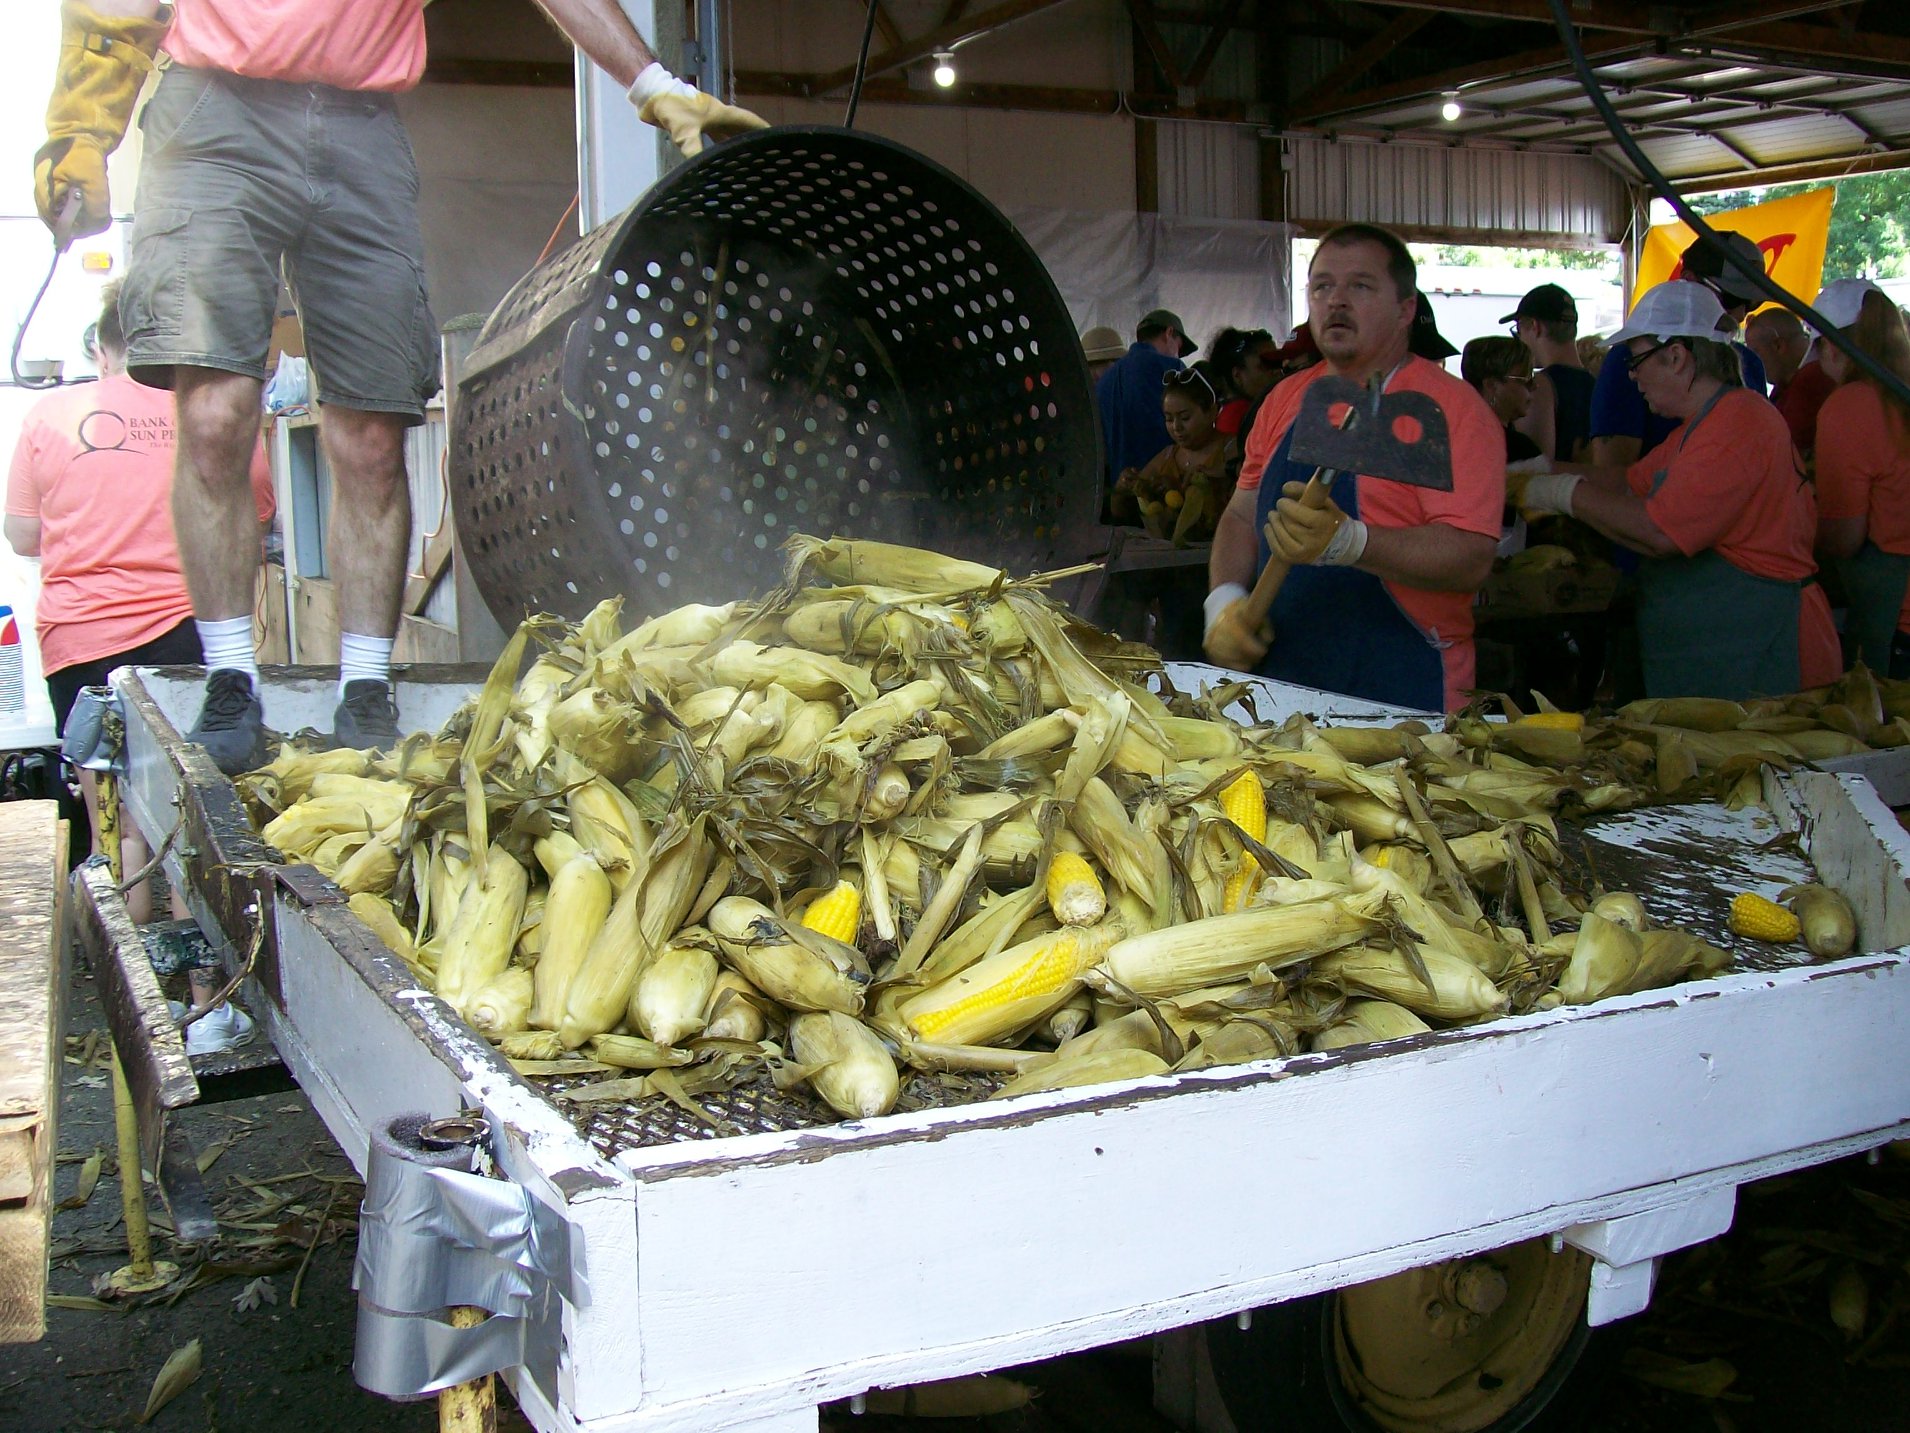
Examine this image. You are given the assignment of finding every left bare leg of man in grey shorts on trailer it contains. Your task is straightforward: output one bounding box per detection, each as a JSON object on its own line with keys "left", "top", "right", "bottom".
{"left": 172, "top": 367, "right": 262, "bottom": 621}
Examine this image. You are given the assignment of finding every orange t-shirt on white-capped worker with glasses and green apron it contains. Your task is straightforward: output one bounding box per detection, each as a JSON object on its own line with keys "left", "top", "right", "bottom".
{"left": 1625, "top": 388, "right": 1843, "bottom": 686}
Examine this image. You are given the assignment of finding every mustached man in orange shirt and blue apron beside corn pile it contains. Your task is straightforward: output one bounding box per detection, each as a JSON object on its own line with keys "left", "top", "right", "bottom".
{"left": 1205, "top": 224, "right": 1505, "bottom": 711}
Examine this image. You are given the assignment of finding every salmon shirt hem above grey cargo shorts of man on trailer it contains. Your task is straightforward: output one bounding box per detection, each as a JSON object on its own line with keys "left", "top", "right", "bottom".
{"left": 164, "top": 0, "right": 424, "bottom": 90}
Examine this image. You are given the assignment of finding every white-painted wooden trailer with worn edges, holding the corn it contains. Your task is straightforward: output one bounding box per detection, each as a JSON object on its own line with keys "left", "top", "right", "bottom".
{"left": 100, "top": 669, "right": 1910, "bottom": 1433}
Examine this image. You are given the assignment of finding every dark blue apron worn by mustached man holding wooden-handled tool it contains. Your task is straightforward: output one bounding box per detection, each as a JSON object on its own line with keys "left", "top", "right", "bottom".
{"left": 1253, "top": 430, "right": 1446, "bottom": 711}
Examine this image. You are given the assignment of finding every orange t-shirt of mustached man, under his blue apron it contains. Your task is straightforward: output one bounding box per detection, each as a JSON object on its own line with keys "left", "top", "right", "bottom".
{"left": 1236, "top": 357, "right": 1505, "bottom": 711}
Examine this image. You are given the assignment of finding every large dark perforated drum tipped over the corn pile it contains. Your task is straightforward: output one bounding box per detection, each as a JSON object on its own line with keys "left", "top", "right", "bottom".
{"left": 451, "top": 128, "right": 1100, "bottom": 623}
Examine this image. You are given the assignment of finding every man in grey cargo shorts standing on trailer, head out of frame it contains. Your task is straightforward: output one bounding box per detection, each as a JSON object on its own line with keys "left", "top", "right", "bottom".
{"left": 34, "top": 0, "right": 762, "bottom": 774}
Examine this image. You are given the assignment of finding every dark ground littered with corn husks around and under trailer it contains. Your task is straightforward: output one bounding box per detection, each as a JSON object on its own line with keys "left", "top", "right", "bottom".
{"left": 0, "top": 978, "right": 1910, "bottom": 1433}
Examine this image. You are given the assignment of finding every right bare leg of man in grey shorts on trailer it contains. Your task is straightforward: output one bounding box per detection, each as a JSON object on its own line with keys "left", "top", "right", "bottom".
{"left": 322, "top": 407, "right": 411, "bottom": 636}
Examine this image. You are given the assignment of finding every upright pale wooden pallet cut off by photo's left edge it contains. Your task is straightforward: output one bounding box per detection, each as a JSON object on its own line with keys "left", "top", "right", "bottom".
{"left": 0, "top": 801, "right": 67, "bottom": 1343}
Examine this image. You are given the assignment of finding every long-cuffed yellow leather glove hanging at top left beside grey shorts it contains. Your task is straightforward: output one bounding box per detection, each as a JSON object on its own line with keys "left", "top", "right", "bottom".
{"left": 32, "top": 0, "right": 170, "bottom": 237}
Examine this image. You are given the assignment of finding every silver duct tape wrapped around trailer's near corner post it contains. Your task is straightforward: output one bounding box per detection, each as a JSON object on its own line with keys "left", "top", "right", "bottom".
{"left": 351, "top": 1114, "right": 573, "bottom": 1399}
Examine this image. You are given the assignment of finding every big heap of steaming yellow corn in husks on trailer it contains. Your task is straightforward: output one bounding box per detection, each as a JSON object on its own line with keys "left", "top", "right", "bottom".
{"left": 243, "top": 537, "right": 1864, "bottom": 1118}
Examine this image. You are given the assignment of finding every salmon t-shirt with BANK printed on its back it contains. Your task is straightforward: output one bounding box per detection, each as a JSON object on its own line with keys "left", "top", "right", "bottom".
{"left": 6, "top": 374, "right": 273, "bottom": 673}
